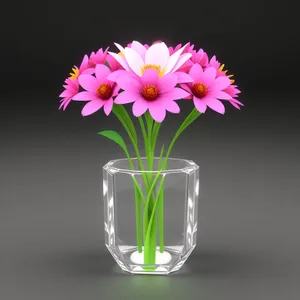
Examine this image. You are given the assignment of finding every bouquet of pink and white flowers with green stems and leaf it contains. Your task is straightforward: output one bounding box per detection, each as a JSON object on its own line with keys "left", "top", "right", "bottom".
{"left": 59, "top": 41, "right": 243, "bottom": 272}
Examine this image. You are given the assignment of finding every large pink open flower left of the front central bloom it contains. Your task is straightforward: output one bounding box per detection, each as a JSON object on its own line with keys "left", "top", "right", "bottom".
{"left": 73, "top": 65, "right": 119, "bottom": 116}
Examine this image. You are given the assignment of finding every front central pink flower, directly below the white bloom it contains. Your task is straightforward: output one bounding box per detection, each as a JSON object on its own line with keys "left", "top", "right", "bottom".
{"left": 115, "top": 69, "right": 189, "bottom": 122}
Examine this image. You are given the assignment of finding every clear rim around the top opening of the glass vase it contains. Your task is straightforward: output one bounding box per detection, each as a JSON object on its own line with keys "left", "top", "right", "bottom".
{"left": 103, "top": 157, "right": 199, "bottom": 175}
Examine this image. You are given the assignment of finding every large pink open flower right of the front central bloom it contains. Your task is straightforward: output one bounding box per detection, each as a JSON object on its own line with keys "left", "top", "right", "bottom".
{"left": 181, "top": 64, "right": 232, "bottom": 114}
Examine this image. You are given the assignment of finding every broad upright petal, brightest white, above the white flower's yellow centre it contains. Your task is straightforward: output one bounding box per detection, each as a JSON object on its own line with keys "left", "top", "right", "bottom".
{"left": 145, "top": 43, "right": 170, "bottom": 69}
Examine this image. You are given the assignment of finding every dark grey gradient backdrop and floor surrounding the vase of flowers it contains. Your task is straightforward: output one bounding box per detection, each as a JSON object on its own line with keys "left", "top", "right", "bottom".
{"left": 0, "top": 0, "right": 300, "bottom": 300}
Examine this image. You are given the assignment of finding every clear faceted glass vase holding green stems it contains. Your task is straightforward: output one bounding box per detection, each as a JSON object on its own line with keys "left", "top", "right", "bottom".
{"left": 103, "top": 158, "right": 199, "bottom": 274}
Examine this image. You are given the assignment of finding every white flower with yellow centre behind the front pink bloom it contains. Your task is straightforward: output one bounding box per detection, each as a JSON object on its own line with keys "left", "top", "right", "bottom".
{"left": 109, "top": 41, "right": 192, "bottom": 77}
